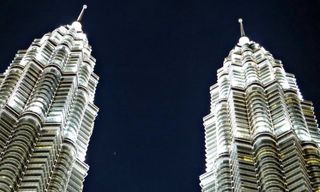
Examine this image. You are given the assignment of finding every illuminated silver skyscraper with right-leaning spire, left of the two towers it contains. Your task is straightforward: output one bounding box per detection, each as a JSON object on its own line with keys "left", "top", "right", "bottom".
{"left": 0, "top": 6, "right": 99, "bottom": 192}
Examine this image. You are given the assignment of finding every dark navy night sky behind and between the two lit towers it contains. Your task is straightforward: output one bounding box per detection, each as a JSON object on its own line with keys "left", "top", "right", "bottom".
{"left": 0, "top": 0, "right": 320, "bottom": 192}
